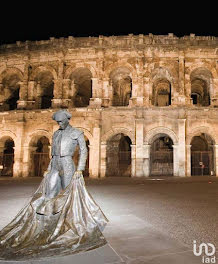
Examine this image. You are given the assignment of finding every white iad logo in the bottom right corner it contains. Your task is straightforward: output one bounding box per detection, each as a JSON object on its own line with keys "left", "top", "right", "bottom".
{"left": 193, "top": 240, "right": 216, "bottom": 263}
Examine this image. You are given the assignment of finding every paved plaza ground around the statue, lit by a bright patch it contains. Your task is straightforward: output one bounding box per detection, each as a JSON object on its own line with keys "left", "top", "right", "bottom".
{"left": 0, "top": 177, "right": 218, "bottom": 264}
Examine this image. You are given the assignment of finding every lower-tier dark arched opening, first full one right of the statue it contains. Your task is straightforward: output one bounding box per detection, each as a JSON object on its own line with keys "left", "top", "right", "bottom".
{"left": 106, "top": 133, "right": 132, "bottom": 177}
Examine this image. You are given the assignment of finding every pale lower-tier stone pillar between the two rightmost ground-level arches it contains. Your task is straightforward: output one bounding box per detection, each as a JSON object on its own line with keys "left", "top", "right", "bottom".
{"left": 177, "top": 119, "right": 186, "bottom": 177}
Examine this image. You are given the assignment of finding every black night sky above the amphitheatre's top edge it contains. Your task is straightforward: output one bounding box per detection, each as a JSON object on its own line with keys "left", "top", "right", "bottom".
{"left": 0, "top": 1, "right": 218, "bottom": 44}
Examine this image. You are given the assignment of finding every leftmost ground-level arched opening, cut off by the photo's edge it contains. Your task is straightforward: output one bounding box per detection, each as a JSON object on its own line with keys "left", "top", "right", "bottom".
{"left": 0, "top": 137, "right": 14, "bottom": 177}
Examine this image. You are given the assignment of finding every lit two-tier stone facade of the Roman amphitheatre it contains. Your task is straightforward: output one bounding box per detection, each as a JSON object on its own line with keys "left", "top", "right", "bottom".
{"left": 0, "top": 33, "right": 218, "bottom": 178}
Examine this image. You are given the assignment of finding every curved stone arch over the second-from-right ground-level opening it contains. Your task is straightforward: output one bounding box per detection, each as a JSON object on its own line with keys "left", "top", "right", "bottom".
{"left": 144, "top": 127, "right": 178, "bottom": 145}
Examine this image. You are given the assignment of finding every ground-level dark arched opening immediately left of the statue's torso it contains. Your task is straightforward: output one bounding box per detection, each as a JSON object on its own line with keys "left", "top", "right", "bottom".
{"left": 30, "top": 136, "right": 50, "bottom": 177}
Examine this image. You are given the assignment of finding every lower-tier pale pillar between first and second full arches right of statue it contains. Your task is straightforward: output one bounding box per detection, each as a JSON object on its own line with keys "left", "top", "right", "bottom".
{"left": 135, "top": 119, "right": 144, "bottom": 177}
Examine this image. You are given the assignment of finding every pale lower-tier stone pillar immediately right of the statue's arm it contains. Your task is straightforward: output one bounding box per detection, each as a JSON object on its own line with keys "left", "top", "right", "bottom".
{"left": 89, "top": 127, "right": 102, "bottom": 178}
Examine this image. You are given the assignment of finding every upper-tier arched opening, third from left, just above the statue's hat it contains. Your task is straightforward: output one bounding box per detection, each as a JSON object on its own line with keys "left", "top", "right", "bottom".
{"left": 70, "top": 68, "right": 92, "bottom": 107}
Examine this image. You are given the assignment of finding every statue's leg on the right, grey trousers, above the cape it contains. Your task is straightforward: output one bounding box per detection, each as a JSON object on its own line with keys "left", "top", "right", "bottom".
{"left": 60, "top": 156, "right": 75, "bottom": 189}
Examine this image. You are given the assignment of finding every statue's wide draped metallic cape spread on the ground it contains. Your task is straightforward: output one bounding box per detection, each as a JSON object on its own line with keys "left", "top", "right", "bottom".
{"left": 0, "top": 175, "right": 108, "bottom": 260}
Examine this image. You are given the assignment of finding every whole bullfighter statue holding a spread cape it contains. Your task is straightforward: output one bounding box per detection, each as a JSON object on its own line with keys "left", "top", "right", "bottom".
{"left": 0, "top": 110, "right": 108, "bottom": 260}
